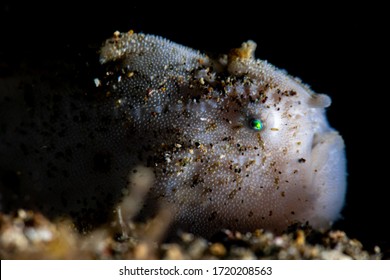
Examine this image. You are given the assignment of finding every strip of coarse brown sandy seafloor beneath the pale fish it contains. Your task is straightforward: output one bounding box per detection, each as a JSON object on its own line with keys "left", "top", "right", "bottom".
{"left": 0, "top": 210, "right": 383, "bottom": 260}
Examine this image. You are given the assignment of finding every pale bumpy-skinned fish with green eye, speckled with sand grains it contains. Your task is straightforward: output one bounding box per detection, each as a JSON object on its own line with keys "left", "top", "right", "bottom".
{"left": 0, "top": 32, "right": 346, "bottom": 235}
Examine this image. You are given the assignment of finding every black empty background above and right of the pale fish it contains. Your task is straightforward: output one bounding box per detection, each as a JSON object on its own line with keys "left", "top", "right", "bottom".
{"left": 0, "top": 1, "right": 390, "bottom": 254}
